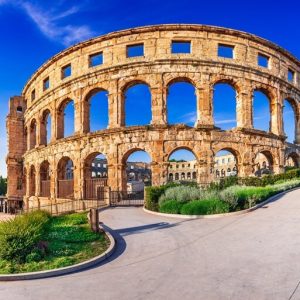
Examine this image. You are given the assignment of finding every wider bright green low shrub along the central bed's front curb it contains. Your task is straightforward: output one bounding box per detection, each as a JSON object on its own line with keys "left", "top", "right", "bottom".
{"left": 180, "top": 200, "right": 229, "bottom": 215}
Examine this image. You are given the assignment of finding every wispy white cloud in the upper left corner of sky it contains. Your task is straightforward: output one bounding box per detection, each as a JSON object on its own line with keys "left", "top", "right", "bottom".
{"left": 0, "top": 0, "right": 94, "bottom": 46}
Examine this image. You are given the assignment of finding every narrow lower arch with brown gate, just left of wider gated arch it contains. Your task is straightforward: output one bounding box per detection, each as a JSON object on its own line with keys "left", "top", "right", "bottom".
{"left": 57, "top": 157, "right": 74, "bottom": 199}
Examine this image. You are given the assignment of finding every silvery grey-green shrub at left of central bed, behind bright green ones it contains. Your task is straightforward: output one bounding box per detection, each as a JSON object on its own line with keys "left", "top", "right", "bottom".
{"left": 159, "top": 186, "right": 201, "bottom": 204}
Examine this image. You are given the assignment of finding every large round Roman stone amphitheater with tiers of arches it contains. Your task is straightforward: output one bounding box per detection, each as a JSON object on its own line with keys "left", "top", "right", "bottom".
{"left": 7, "top": 25, "right": 300, "bottom": 210}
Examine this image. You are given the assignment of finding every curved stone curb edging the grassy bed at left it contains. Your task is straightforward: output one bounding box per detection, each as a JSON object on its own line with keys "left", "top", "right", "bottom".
{"left": 0, "top": 226, "right": 116, "bottom": 281}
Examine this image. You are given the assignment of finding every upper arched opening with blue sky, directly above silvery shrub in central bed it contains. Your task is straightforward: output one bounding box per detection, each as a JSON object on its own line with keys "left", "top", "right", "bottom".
{"left": 167, "top": 79, "right": 197, "bottom": 127}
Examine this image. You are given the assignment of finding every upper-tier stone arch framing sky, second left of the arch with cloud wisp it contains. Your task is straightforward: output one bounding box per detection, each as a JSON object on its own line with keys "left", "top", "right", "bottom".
{"left": 121, "top": 79, "right": 152, "bottom": 126}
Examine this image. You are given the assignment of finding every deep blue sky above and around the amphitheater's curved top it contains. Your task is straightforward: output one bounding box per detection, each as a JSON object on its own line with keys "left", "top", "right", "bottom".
{"left": 0, "top": 0, "right": 300, "bottom": 175}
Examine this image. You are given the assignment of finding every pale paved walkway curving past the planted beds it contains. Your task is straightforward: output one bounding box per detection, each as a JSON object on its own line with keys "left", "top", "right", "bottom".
{"left": 0, "top": 190, "right": 300, "bottom": 300}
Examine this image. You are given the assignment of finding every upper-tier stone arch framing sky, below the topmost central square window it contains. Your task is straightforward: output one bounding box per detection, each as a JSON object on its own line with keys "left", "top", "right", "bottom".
{"left": 166, "top": 76, "right": 198, "bottom": 127}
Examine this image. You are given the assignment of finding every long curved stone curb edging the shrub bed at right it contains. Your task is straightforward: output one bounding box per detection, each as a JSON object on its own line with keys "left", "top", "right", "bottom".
{"left": 143, "top": 187, "right": 300, "bottom": 219}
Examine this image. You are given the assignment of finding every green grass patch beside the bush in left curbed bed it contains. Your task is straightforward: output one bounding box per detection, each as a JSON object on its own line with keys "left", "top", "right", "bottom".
{"left": 0, "top": 213, "right": 109, "bottom": 274}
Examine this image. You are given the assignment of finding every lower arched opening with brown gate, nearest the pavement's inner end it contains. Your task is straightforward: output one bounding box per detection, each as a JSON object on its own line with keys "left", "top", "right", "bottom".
{"left": 84, "top": 152, "right": 108, "bottom": 200}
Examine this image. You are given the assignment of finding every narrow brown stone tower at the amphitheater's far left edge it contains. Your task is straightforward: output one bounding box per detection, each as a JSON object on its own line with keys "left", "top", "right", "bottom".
{"left": 6, "top": 96, "right": 26, "bottom": 208}
